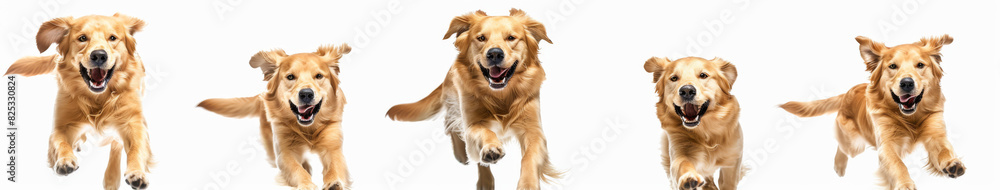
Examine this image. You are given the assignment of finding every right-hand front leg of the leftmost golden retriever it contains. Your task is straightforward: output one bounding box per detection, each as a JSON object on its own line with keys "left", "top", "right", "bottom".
{"left": 118, "top": 117, "right": 153, "bottom": 189}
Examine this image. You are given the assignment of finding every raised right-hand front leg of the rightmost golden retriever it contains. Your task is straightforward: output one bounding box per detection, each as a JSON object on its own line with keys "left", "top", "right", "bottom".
{"left": 920, "top": 112, "right": 965, "bottom": 178}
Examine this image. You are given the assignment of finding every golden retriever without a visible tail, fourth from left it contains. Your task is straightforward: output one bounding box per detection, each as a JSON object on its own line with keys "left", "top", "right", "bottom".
{"left": 643, "top": 57, "right": 746, "bottom": 190}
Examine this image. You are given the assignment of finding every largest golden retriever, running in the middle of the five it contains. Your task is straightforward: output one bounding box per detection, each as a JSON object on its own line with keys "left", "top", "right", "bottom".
{"left": 386, "top": 9, "right": 560, "bottom": 189}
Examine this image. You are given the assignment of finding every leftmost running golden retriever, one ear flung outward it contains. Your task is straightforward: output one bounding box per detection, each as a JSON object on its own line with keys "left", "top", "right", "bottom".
{"left": 7, "top": 14, "right": 153, "bottom": 189}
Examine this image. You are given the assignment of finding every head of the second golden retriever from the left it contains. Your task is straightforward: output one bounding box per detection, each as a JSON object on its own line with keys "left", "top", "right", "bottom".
{"left": 250, "top": 44, "right": 351, "bottom": 126}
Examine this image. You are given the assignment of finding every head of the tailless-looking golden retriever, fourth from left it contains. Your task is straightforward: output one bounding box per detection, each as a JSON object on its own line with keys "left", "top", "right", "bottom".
{"left": 644, "top": 57, "right": 736, "bottom": 129}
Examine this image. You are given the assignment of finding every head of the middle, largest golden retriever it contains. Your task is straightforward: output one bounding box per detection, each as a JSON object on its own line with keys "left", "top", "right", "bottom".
{"left": 444, "top": 9, "right": 552, "bottom": 90}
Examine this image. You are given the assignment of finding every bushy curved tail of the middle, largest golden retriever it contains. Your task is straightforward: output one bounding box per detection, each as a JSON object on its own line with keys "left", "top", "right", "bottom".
{"left": 385, "top": 84, "right": 444, "bottom": 121}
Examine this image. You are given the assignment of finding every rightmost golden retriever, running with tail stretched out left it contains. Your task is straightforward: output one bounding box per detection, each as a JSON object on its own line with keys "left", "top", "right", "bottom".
{"left": 781, "top": 35, "right": 965, "bottom": 189}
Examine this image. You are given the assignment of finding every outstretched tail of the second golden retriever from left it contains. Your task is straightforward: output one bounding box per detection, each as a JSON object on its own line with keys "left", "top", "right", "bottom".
{"left": 198, "top": 96, "right": 264, "bottom": 118}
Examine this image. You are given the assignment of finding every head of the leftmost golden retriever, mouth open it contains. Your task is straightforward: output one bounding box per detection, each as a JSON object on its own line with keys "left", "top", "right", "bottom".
{"left": 36, "top": 14, "right": 146, "bottom": 94}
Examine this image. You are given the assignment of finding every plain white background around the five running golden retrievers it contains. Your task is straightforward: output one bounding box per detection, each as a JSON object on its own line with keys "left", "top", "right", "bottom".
{"left": 0, "top": 0, "right": 1000, "bottom": 189}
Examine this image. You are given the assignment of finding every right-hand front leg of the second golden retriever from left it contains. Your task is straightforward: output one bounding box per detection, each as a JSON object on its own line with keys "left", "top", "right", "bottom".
{"left": 316, "top": 123, "right": 350, "bottom": 190}
